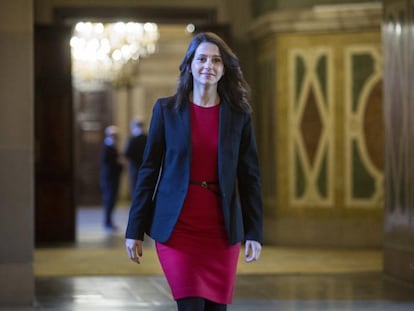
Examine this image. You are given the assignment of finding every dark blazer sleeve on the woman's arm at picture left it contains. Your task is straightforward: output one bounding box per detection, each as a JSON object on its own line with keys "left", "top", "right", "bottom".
{"left": 125, "top": 99, "right": 165, "bottom": 240}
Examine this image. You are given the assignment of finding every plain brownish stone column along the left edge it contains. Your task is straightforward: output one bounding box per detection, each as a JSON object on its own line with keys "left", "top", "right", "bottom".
{"left": 0, "top": 0, "right": 34, "bottom": 306}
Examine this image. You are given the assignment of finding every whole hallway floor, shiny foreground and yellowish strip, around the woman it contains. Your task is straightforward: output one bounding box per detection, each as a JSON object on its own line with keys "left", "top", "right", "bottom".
{"left": 5, "top": 207, "right": 414, "bottom": 311}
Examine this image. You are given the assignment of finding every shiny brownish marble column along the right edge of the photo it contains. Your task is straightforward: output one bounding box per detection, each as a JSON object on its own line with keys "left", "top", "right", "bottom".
{"left": 383, "top": 0, "right": 414, "bottom": 285}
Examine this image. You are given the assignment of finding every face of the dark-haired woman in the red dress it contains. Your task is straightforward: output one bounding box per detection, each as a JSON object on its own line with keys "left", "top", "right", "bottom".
{"left": 191, "top": 42, "right": 224, "bottom": 86}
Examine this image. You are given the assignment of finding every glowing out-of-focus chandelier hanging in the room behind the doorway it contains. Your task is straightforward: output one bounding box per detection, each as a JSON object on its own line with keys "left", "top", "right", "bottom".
{"left": 70, "top": 22, "right": 159, "bottom": 88}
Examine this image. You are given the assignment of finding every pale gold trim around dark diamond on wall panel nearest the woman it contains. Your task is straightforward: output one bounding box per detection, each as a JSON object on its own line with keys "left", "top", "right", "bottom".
{"left": 288, "top": 46, "right": 334, "bottom": 207}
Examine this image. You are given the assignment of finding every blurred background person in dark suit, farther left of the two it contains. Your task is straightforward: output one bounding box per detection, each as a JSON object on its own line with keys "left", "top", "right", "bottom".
{"left": 100, "top": 125, "right": 123, "bottom": 231}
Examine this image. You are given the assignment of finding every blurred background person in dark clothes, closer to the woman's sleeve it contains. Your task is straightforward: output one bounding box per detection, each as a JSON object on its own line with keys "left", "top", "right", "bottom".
{"left": 124, "top": 119, "right": 147, "bottom": 195}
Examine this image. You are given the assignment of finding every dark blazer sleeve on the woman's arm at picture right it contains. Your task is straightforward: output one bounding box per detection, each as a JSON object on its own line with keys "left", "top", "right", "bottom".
{"left": 237, "top": 115, "right": 263, "bottom": 243}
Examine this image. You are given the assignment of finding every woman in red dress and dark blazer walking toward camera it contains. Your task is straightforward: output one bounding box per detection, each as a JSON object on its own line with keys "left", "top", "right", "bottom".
{"left": 125, "top": 33, "right": 263, "bottom": 311}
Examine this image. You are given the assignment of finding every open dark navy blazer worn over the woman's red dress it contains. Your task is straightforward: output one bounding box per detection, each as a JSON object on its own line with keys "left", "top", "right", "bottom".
{"left": 126, "top": 97, "right": 263, "bottom": 244}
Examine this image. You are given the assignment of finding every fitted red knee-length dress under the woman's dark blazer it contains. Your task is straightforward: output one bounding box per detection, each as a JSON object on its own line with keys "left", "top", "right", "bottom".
{"left": 156, "top": 104, "right": 240, "bottom": 304}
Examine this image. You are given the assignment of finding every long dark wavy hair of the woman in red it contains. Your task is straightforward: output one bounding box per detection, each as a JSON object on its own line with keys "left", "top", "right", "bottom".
{"left": 174, "top": 32, "right": 252, "bottom": 113}
